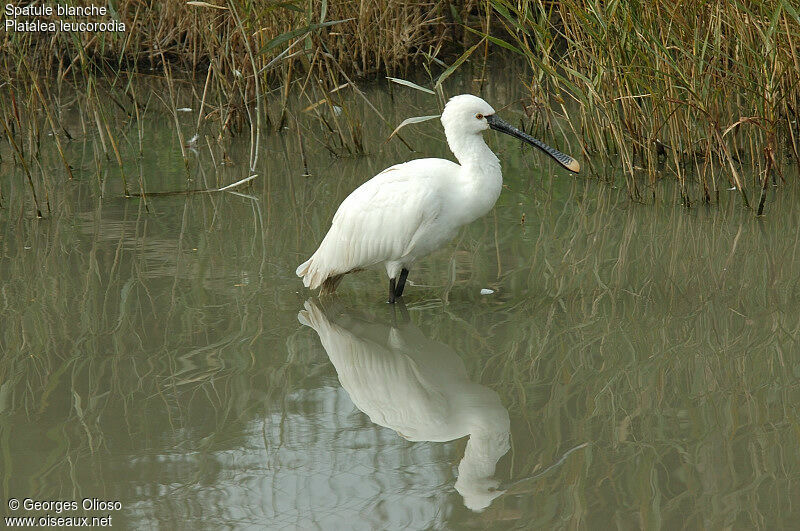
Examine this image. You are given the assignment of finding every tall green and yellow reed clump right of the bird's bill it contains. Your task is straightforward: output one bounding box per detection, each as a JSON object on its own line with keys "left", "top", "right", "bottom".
{"left": 487, "top": 0, "right": 800, "bottom": 209}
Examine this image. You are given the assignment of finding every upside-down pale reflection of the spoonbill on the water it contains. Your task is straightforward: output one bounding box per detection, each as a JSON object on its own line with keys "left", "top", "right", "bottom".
{"left": 298, "top": 300, "right": 510, "bottom": 512}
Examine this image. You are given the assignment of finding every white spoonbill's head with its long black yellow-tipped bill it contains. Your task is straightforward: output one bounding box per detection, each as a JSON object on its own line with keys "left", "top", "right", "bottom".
{"left": 442, "top": 94, "right": 581, "bottom": 173}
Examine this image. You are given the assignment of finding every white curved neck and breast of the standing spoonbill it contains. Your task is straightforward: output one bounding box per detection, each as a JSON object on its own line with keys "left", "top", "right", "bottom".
{"left": 447, "top": 134, "right": 503, "bottom": 223}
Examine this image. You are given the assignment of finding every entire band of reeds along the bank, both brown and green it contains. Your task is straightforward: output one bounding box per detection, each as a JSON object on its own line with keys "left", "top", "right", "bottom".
{"left": 0, "top": 0, "right": 800, "bottom": 212}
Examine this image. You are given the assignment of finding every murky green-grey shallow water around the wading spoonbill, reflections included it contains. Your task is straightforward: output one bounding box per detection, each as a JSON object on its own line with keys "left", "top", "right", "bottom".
{"left": 0, "top": 81, "right": 800, "bottom": 529}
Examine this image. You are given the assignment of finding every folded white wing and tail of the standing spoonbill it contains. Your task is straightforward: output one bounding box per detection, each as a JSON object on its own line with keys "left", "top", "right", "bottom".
{"left": 298, "top": 159, "right": 458, "bottom": 288}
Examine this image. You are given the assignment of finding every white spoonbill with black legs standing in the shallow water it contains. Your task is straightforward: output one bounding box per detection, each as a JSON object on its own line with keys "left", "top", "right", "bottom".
{"left": 296, "top": 94, "right": 580, "bottom": 304}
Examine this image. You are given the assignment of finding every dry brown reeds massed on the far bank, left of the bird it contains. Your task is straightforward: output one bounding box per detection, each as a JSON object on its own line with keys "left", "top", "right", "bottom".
{"left": 0, "top": 0, "right": 456, "bottom": 82}
